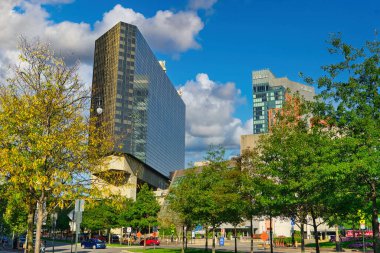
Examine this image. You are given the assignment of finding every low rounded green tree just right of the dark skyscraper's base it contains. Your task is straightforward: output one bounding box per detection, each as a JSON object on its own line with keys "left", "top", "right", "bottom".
{"left": 167, "top": 146, "right": 242, "bottom": 252}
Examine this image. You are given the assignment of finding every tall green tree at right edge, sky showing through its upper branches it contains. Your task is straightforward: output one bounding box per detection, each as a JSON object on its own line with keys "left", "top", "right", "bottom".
{"left": 309, "top": 35, "right": 380, "bottom": 252}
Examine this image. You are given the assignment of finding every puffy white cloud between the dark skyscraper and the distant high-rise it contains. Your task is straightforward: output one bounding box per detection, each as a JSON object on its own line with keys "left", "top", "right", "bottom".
{"left": 181, "top": 74, "right": 252, "bottom": 152}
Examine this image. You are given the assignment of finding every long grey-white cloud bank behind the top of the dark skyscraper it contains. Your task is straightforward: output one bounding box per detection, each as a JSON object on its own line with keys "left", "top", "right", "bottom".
{"left": 0, "top": 0, "right": 204, "bottom": 81}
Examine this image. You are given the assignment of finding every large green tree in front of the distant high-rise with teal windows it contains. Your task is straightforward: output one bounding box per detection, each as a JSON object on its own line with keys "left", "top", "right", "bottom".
{"left": 243, "top": 94, "right": 339, "bottom": 252}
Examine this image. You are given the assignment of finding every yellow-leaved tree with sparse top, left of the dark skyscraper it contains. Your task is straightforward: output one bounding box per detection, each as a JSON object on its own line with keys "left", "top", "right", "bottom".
{"left": 0, "top": 39, "right": 110, "bottom": 253}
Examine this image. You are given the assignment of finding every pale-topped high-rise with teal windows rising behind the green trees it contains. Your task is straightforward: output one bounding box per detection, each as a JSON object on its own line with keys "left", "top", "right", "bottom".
{"left": 252, "top": 70, "right": 315, "bottom": 134}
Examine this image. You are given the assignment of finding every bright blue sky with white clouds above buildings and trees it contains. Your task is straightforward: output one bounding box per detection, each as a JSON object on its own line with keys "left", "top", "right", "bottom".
{"left": 0, "top": 0, "right": 380, "bottom": 166}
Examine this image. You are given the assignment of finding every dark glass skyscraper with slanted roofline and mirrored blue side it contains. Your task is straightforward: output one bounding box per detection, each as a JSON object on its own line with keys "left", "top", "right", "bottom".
{"left": 91, "top": 22, "right": 185, "bottom": 177}
